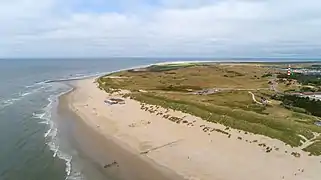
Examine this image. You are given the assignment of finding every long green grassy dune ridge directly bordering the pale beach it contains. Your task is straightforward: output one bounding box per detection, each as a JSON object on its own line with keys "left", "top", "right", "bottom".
{"left": 132, "top": 93, "right": 320, "bottom": 146}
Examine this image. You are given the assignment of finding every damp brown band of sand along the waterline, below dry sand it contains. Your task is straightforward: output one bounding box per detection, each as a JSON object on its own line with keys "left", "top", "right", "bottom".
{"left": 59, "top": 85, "right": 183, "bottom": 180}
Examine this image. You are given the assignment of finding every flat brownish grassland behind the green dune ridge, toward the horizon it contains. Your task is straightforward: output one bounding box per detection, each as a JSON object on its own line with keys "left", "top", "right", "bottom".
{"left": 102, "top": 65, "right": 268, "bottom": 90}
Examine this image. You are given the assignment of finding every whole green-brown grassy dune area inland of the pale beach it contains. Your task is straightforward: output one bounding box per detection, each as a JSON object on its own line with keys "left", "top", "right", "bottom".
{"left": 98, "top": 64, "right": 321, "bottom": 155}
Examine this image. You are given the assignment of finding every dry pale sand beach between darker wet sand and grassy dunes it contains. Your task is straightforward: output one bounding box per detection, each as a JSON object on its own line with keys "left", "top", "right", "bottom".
{"left": 70, "top": 79, "right": 321, "bottom": 180}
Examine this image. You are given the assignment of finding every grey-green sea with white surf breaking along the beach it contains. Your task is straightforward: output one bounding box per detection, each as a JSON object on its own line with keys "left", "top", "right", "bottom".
{"left": 0, "top": 58, "right": 316, "bottom": 180}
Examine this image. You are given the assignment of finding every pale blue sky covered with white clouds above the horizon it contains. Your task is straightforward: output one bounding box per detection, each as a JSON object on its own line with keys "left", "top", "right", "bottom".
{"left": 0, "top": 0, "right": 321, "bottom": 58}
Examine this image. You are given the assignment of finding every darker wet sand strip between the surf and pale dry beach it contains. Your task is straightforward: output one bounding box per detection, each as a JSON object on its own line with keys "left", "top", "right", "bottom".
{"left": 60, "top": 81, "right": 183, "bottom": 180}
